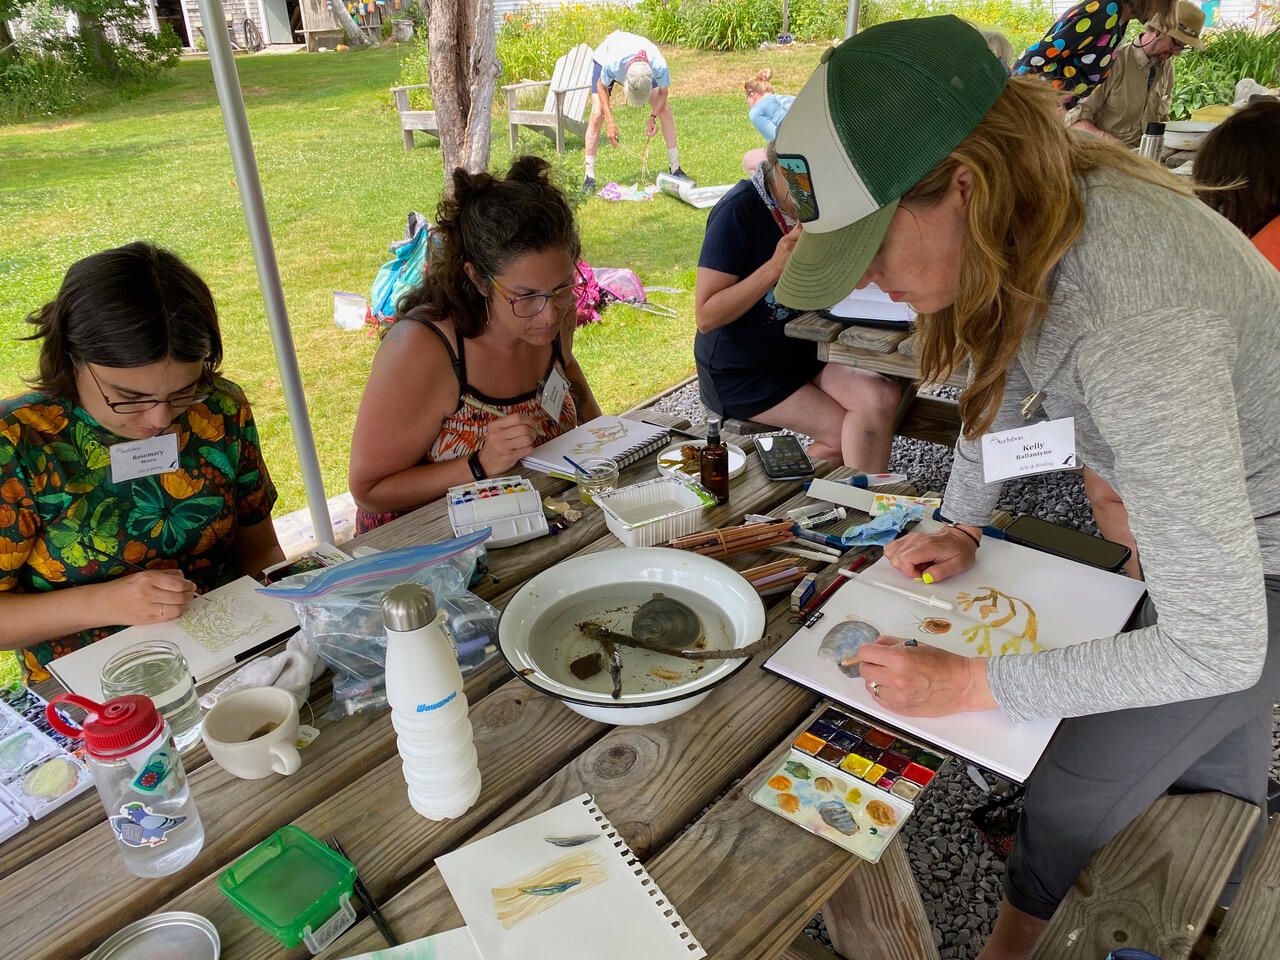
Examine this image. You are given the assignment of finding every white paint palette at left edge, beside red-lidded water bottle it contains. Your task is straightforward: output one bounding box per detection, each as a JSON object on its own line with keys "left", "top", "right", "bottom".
{"left": 0, "top": 684, "right": 93, "bottom": 840}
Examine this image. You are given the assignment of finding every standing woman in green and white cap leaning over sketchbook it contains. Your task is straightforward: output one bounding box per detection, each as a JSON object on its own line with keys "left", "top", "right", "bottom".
{"left": 776, "top": 17, "right": 1280, "bottom": 960}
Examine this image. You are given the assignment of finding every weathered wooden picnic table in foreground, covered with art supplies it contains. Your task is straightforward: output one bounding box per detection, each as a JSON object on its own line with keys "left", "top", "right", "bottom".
{"left": 0, "top": 416, "right": 937, "bottom": 960}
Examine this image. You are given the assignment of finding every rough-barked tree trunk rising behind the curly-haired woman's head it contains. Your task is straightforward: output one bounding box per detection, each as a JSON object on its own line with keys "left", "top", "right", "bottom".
{"left": 428, "top": 0, "right": 498, "bottom": 193}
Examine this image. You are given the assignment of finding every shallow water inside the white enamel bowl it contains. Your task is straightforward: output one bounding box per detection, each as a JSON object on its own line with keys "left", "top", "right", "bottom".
{"left": 529, "top": 584, "right": 733, "bottom": 696}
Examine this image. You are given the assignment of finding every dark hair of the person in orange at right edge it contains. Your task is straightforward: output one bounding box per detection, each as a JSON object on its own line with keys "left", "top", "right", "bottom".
{"left": 1193, "top": 100, "right": 1280, "bottom": 237}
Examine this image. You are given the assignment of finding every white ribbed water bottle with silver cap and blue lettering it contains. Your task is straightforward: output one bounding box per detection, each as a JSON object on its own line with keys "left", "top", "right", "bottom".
{"left": 383, "top": 584, "right": 480, "bottom": 820}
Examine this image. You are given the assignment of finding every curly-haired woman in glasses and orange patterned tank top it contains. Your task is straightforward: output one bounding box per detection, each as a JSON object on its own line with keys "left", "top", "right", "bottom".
{"left": 349, "top": 156, "right": 600, "bottom": 532}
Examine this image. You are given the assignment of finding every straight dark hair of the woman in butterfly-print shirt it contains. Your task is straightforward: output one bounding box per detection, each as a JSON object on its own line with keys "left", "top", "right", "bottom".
{"left": 23, "top": 241, "right": 223, "bottom": 403}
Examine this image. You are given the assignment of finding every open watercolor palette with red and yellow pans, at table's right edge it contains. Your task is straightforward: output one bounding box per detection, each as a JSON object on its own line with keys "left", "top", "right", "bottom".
{"left": 751, "top": 707, "right": 950, "bottom": 863}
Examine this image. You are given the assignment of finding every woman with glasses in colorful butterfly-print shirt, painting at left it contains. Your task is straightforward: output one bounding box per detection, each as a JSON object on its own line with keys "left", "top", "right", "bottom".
{"left": 0, "top": 243, "right": 284, "bottom": 681}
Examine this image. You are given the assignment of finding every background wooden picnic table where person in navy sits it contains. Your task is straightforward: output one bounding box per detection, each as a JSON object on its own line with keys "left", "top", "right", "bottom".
{"left": 786, "top": 311, "right": 968, "bottom": 447}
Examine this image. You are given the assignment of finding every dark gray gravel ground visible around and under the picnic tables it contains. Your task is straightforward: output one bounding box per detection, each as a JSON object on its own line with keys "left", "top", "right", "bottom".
{"left": 654, "top": 384, "right": 1280, "bottom": 960}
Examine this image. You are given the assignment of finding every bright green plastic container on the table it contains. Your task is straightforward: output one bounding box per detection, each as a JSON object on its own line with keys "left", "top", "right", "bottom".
{"left": 218, "top": 824, "right": 356, "bottom": 954}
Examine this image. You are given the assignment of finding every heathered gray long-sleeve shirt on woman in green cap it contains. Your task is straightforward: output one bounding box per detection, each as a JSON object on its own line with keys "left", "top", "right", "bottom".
{"left": 942, "top": 163, "right": 1280, "bottom": 721}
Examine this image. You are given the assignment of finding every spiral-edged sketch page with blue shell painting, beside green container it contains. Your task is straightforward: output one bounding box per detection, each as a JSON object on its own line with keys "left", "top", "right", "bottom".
{"left": 435, "top": 794, "right": 707, "bottom": 960}
